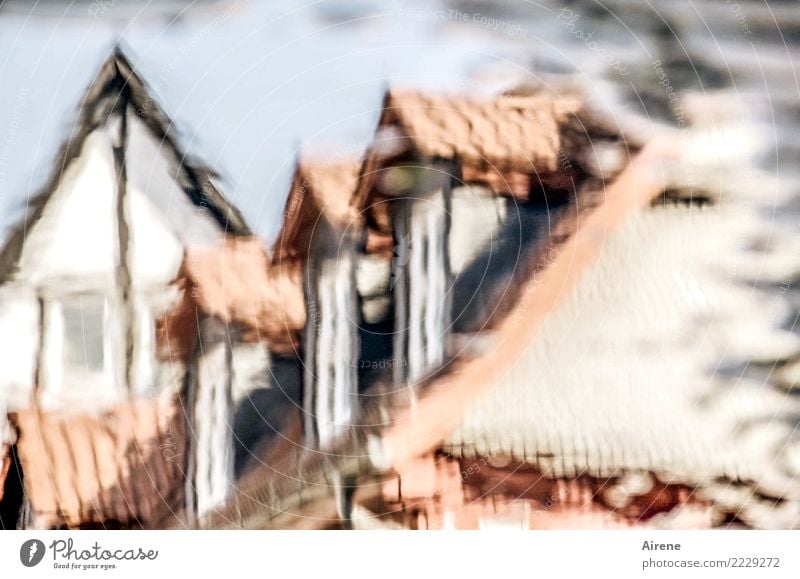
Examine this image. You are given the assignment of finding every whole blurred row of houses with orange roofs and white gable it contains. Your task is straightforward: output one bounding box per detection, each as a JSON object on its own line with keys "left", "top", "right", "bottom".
{"left": 0, "top": 45, "right": 800, "bottom": 528}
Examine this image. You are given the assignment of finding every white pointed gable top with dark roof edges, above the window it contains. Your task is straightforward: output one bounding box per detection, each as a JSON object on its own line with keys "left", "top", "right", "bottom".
{"left": 0, "top": 48, "right": 250, "bottom": 282}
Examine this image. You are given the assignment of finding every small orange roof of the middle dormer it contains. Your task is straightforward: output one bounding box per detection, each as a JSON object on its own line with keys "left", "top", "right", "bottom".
{"left": 272, "top": 156, "right": 360, "bottom": 262}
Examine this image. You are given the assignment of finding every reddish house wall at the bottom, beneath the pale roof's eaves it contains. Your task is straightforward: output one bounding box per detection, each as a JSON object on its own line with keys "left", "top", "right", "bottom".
{"left": 382, "top": 454, "right": 719, "bottom": 530}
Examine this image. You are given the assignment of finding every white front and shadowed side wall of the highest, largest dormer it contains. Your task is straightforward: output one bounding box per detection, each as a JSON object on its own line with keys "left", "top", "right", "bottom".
{"left": 382, "top": 170, "right": 565, "bottom": 384}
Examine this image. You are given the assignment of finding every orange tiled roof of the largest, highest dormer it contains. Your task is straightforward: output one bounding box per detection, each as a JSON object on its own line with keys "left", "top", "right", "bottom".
{"left": 356, "top": 89, "right": 633, "bottom": 207}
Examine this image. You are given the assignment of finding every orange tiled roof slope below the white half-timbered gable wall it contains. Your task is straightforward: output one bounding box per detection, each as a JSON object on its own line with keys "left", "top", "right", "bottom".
{"left": 11, "top": 399, "right": 187, "bottom": 528}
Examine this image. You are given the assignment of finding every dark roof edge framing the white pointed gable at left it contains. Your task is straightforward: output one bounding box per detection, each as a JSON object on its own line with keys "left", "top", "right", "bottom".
{"left": 0, "top": 47, "right": 250, "bottom": 283}
